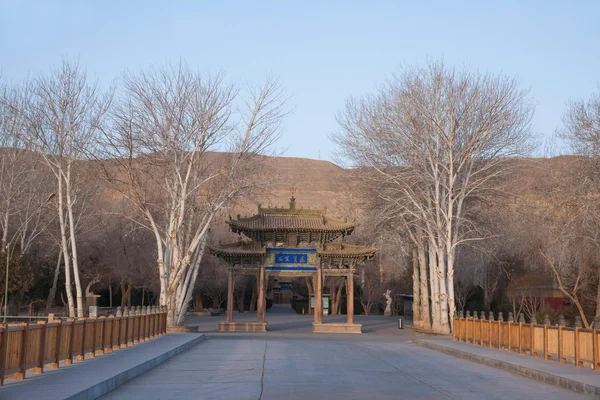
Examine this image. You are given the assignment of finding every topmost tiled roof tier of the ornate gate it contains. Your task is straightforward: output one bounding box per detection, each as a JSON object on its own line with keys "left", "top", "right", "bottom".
{"left": 227, "top": 214, "right": 354, "bottom": 232}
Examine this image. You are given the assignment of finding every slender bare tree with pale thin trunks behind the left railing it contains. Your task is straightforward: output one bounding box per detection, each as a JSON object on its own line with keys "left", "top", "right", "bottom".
{"left": 22, "top": 61, "right": 111, "bottom": 317}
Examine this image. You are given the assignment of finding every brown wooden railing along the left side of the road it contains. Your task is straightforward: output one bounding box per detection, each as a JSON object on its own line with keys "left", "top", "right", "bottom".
{"left": 0, "top": 307, "right": 167, "bottom": 386}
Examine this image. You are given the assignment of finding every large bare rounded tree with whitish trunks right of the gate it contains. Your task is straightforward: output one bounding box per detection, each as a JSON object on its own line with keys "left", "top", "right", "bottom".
{"left": 333, "top": 62, "right": 533, "bottom": 332}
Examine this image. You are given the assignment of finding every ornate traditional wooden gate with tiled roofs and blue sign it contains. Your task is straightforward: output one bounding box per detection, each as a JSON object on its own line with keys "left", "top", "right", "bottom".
{"left": 210, "top": 195, "right": 375, "bottom": 333}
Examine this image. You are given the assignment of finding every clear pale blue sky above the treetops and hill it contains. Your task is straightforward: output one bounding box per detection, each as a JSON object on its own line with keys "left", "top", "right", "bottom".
{"left": 0, "top": 0, "right": 600, "bottom": 159}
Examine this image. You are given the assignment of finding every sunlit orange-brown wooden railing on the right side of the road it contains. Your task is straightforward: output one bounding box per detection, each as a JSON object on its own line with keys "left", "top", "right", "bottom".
{"left": 453, "top": 312, "right": 600, "bottom": 371}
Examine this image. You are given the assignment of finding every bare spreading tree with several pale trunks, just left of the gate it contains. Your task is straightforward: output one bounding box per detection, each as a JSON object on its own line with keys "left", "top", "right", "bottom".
{"left": 105, "top": 64, "right": 284, "bottom": 326}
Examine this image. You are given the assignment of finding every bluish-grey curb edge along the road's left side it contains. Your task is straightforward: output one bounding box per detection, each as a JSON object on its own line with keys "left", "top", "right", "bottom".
{"left": 67, "top": 334, "right": 206, "bottom": 400}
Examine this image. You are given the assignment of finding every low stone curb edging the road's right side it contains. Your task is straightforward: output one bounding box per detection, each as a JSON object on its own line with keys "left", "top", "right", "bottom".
{"left": 412, "top": 339, "right": 600, "bottom": 397}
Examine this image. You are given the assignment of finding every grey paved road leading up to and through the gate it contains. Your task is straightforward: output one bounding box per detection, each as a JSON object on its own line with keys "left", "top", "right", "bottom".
{"left": 105, "top": 308, "right": 585, "bottom": 400}
